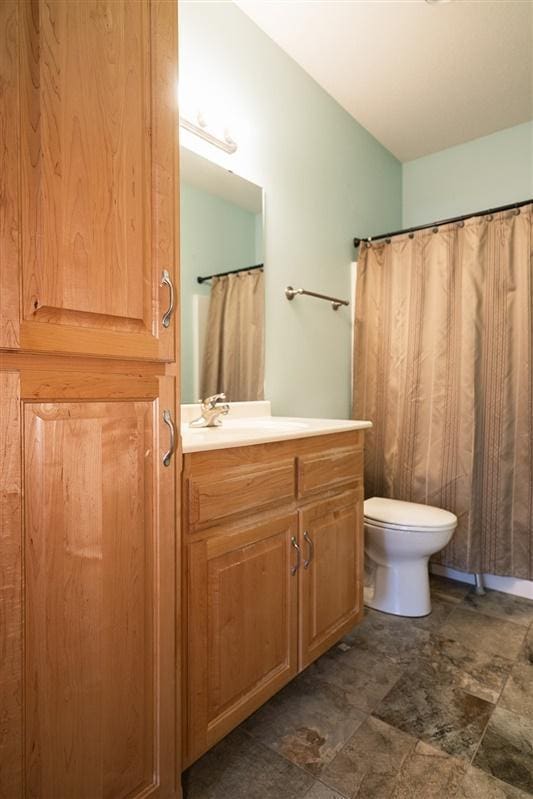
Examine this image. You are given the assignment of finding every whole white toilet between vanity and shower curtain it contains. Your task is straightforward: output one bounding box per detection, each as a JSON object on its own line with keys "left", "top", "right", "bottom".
{"left": 364, "top": 497, "right": 457, "bottom": 616}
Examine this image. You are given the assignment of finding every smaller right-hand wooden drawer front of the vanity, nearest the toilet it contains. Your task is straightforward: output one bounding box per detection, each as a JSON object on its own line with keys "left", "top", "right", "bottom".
{"left": 297, "top": 447, "right": 363, "bottom": 498}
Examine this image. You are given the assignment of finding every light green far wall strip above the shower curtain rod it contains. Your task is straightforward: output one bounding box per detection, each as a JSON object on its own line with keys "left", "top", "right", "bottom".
{"left": 403, "top": 122, "right": 533, "bottom": 227}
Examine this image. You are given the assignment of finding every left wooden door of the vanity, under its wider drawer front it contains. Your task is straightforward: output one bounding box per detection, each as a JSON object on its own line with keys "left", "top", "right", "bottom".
{"left": 185, "top": 513, "right": 298, "bottom": 765}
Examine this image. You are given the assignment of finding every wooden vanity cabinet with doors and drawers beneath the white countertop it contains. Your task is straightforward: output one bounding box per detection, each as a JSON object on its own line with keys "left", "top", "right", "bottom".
{"left": 183, "top": 430, "right": 364, "bottom": 766}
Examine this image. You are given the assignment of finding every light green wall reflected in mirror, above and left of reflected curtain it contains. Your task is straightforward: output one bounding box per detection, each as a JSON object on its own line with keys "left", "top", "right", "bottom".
{"left": 180, "top": 182, "right": 261, "bottom": 402}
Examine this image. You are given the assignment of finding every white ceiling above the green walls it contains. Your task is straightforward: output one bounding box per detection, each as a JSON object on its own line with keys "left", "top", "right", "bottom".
{"left": 235, "top": 0, "right": 533, "bottom": 161}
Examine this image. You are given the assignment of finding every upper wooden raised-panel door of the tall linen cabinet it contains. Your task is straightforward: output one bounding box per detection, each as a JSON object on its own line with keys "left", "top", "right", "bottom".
{"left": 0, "top": 0, "right": 178, "bottom": 361}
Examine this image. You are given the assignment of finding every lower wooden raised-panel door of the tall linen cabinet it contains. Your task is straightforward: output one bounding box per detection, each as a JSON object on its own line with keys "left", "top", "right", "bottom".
{"left": 0, "top": 372, "right": 176, "bottom": 799}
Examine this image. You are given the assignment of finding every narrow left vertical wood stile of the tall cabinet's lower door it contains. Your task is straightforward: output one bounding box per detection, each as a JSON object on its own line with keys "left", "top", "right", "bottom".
{"left": 0, "top": 372, "right": 23, "bottom": 799}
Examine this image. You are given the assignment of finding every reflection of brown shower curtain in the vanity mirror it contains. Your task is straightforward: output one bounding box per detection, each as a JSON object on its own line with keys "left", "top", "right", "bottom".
{"left": 200, "top": 269, "right": 265, "bottom": 402}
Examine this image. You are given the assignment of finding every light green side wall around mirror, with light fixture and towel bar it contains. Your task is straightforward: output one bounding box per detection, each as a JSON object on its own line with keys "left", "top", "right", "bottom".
{"left": 180, "top": 2, "right": 401, "bottom": 418}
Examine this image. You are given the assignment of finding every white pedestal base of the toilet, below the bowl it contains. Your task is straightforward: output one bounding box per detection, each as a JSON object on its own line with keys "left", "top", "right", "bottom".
{"left": 364, "top": 558, "right": 431, "bottom": 618}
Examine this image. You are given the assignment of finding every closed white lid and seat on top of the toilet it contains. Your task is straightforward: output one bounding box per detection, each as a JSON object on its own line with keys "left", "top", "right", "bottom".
{"left": 364, "top": 497, "right": 457, "bottom": 530}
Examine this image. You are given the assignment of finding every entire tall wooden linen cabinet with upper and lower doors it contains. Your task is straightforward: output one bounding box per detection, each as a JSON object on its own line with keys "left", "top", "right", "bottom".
{"left": 0, "top": 0, "right": 181, "bottom": 799}
